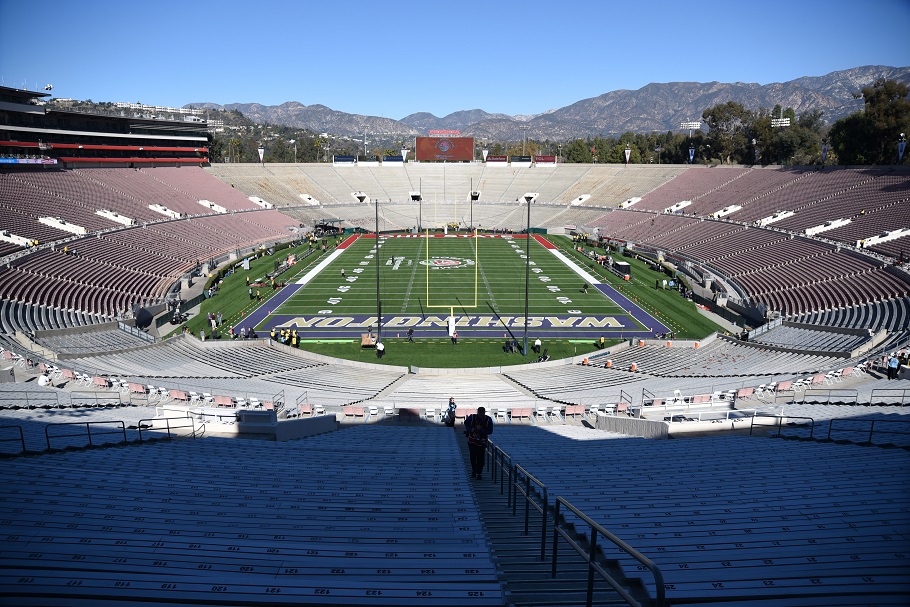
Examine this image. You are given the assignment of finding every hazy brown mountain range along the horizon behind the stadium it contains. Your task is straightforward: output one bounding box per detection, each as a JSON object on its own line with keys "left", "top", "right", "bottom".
{"left": 187, "top": 66, "right": 910, "bottom": 141}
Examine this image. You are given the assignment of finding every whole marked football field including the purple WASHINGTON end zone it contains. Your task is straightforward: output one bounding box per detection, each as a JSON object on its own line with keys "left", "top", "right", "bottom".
{"left": 242, "top": 235, "right": 666, "bottom": 339}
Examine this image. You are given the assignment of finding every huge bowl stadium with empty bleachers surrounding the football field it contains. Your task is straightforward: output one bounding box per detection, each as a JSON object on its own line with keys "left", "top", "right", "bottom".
{"left": 0, "top": 82, "right": 910, "bottom": 607}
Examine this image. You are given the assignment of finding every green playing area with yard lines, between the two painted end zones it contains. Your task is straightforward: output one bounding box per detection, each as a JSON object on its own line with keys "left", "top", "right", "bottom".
{"left": 273, "top": 237, "right": 626, "bottom": 324}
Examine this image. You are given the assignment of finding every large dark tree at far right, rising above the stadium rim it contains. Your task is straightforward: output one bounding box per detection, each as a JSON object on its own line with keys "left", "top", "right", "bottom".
{"left": 830, "top": 78, "right": 910, "bottom": 164}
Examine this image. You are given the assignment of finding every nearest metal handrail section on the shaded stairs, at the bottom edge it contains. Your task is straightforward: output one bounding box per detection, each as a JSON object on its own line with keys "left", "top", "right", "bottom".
{"left": 550, "top": 497, "right": 666, "bottom": 607}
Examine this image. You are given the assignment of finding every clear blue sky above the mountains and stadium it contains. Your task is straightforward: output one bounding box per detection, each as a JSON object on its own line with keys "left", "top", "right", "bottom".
{"left": 0, "top": 0, "right": 910, "bottom": 120}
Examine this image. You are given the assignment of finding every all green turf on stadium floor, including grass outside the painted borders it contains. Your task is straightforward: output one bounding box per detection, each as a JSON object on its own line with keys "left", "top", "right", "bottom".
{"left": 175, "top": 236, "right": 718, "bottom": 367}
